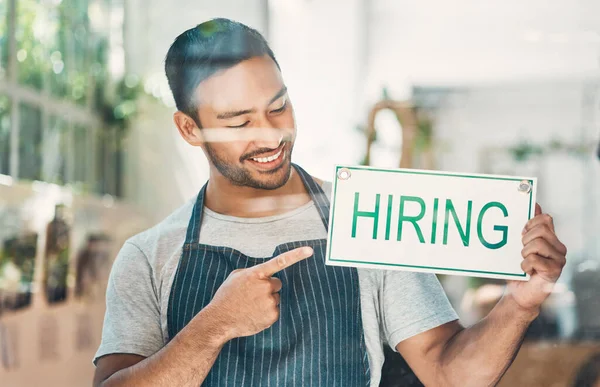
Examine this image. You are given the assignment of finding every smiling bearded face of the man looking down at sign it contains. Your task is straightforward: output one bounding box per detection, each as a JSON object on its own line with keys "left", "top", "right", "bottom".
{"left": 196, "top": 56, "right": 296, "bottom": 189}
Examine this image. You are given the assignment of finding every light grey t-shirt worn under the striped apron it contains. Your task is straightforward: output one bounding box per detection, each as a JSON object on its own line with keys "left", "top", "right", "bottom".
{"left": 94, "top": 182, "right": 458, "bottom": 386}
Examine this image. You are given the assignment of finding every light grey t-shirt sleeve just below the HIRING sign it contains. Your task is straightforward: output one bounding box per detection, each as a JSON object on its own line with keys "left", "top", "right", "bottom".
{"left": 380, "top": 271, "right": 458, "bottom": 351}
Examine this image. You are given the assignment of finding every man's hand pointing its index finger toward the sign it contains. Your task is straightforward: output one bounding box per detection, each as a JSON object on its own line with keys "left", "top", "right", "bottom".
{"left": 208, "top": 247, "right": 313, "bottom": 341}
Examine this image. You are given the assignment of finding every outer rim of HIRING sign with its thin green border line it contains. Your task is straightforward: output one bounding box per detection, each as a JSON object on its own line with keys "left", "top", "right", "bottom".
{"left": 326, "top": 165, "right": 534, "bottom": 278}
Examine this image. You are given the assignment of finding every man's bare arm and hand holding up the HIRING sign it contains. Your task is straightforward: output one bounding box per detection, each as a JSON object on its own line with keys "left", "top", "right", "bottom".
{"left": 396, "top": 205, "right": 567, "bottom": 387}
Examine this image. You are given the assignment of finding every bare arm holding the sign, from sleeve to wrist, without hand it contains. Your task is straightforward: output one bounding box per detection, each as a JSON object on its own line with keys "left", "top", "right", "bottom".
{"left": 396, "top": 295, "right": 537, "bottom": 387}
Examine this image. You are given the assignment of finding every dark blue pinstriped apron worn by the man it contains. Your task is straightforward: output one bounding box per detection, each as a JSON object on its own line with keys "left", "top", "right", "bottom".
{"left": 167, "top": 165, "right": 370, "bottom": 387}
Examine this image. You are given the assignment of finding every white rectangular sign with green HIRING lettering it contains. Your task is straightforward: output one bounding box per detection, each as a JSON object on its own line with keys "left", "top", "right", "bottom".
{"left": 326, "top": 166, "right": 537, "bottom": 280}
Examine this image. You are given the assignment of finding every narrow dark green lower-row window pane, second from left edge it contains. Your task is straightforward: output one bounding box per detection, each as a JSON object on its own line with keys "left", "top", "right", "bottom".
{"left": 19, "top": 103, "right": 42, "bottom": 180}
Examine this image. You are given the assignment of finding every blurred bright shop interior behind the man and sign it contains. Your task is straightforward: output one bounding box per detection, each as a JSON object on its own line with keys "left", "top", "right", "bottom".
{"left": 0, "top": 0, "right": 600, "bottom": 387}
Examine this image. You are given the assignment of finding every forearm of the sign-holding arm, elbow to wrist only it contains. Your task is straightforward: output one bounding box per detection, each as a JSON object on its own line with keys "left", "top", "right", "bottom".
{"left": 441, "top": 295, "right": 538, "bottom": 387}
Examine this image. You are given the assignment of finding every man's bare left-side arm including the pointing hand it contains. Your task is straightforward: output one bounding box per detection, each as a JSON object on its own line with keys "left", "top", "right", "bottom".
{"left": 94, "top": 247, "right": 313, "bottom": 387}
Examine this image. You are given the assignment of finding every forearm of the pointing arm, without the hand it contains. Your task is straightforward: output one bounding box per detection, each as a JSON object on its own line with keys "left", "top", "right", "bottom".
{"left": 101, "top": 309, "right": 227, "bottom": 387}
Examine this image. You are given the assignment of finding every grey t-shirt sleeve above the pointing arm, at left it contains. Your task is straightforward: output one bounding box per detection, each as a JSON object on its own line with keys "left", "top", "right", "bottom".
{"left": 94, "top": 241, "right": 163, "bottom": 364}
